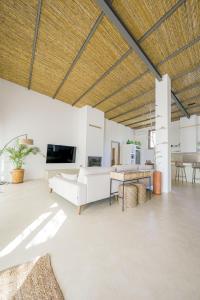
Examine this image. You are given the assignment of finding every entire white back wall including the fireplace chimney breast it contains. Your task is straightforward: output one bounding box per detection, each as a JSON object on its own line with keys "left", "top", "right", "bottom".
{"left": 0, "top": 79, "right": 133, "bottom": 180}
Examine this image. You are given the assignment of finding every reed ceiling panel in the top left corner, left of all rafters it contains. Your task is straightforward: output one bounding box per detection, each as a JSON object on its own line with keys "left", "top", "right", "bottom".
{"left": 0, "top": 0, "right": 37, "bottom": 87}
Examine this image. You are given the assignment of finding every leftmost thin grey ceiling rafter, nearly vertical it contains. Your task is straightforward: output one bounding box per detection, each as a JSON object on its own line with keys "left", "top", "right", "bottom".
{"left": 28, "top": 0, "right": 42, "bottom": 90}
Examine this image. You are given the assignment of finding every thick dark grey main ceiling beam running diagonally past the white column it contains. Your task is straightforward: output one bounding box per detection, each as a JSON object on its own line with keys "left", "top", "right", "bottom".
{"left": 96, "top": 0, "right": 190, "bottom": 118}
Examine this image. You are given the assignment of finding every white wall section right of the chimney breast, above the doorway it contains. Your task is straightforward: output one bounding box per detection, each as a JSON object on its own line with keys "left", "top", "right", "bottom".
{"left": 103, "top": 119, "right": 134, "bottom": 166}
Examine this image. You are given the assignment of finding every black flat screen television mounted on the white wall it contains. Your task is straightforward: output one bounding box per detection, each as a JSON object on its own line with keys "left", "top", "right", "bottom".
{"left": 46, "top": 144, "right": 76, "bottom": 164}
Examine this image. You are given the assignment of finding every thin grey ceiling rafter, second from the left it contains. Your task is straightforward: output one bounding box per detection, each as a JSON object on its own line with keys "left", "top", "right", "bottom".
{"left": 53, "top": 12, "right": 104, "bottom": 99}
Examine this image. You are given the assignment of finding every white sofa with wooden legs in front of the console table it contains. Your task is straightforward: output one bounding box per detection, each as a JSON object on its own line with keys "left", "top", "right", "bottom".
{"left": 49, "top": 165, "right": 153, "bottom": 214}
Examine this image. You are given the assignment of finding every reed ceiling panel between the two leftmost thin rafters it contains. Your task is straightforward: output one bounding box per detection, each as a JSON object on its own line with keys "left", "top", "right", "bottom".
{"left": 32, "top": 0, "right": 100, "bottom": 96}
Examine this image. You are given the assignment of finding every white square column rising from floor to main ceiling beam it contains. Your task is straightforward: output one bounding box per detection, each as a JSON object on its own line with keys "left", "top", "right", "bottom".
{"left": 155, "top": 75, "right": 171, "bottom": 193}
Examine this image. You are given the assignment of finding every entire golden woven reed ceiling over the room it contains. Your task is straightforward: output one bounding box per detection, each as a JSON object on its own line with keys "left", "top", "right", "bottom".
{"left": 0, "top": 0, "right": 200, "bottom": 128}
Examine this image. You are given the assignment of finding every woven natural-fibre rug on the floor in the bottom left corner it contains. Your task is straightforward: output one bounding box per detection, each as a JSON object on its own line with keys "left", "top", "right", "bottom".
{"left": 0, "top": 254, "right": 64, "bottom": 300}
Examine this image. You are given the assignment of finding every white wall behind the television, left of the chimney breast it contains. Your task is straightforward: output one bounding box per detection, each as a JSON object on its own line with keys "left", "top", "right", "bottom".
{"left": 0, "top": 80, "right": 78, "bottom": 178}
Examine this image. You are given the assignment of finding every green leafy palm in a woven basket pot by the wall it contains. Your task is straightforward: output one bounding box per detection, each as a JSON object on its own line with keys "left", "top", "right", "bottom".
{"left": 5, "top": 140, "right": 40, "bottom": 183}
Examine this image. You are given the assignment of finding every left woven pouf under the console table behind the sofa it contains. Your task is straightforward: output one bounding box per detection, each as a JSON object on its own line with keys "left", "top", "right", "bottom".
{"left": 118, "top": 184, "right": 138, "bottom": 208}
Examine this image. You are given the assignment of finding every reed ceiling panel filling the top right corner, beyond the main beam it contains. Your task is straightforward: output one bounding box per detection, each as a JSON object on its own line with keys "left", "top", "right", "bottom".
{"left": 141, "top": 0, "right": 200, "bottom": 64}
